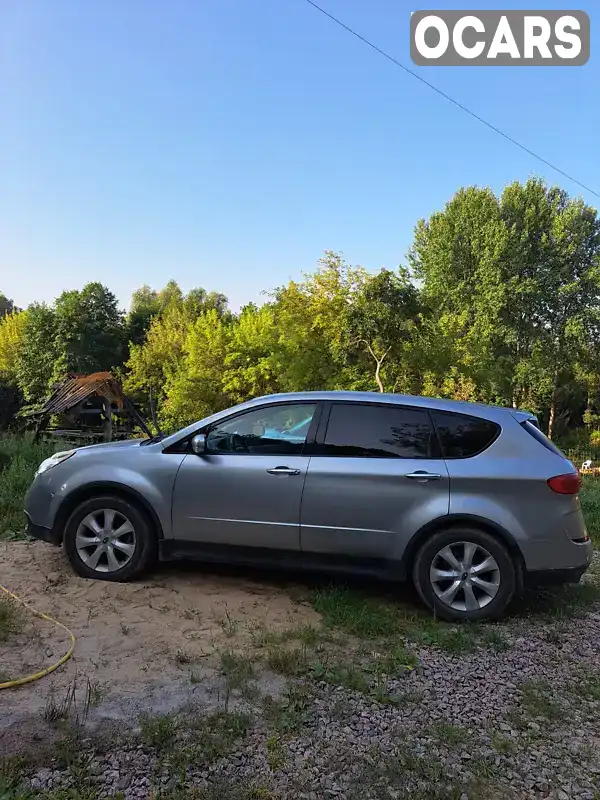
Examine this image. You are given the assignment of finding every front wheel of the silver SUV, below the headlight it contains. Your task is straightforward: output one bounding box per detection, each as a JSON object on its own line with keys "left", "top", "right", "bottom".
{"left": 64, "top": 495, "right": 158, "bottom": 581}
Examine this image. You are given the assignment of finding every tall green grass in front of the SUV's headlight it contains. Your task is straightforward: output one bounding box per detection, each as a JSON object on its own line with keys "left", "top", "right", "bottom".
{"left": 0, "top": 434, "right": 57, "bottom": 539}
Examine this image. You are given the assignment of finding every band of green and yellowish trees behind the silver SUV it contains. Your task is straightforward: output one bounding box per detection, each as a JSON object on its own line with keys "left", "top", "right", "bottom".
{"left": 0, "top": 178, "right": 600, "bottom": 444}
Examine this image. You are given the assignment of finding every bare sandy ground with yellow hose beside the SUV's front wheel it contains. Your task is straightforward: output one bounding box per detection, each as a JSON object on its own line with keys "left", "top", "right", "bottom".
{"left": 0, "top": 542, "right": 317, "bottom": 736}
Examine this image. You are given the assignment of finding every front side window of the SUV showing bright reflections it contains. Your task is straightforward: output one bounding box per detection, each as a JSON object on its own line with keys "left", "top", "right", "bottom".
{"left": 206, "top": 403, "right": 316, "bottom": 455}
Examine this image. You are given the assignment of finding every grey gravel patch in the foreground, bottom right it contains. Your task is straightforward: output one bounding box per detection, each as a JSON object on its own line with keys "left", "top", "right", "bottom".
{"left": 18, "top": 600, "right": 600, "bottom": 800}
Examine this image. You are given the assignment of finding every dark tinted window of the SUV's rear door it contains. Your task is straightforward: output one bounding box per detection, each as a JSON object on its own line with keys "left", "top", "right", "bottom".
{"left": 324, "top": 403, "right": 431, "bottom": 458}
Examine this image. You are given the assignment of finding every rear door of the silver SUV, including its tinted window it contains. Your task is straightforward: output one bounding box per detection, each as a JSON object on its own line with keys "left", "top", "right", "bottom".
{"left": 301, "top": 402, "right": 450, "bottom": 559}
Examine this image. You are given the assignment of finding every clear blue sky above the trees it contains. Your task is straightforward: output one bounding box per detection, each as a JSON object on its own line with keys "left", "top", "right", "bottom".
{"left": 0, "top": 0, "right": 600, "bottom": 307}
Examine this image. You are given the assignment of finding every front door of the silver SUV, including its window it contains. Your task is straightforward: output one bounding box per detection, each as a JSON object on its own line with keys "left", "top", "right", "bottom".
{"left": 173, "top": 403, "right": 317, "bottom": 550}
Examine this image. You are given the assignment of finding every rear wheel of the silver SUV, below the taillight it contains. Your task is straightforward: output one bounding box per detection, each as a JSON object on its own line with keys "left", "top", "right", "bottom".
{"left": 413, "top": 527, "right": 518, "bottom": 622}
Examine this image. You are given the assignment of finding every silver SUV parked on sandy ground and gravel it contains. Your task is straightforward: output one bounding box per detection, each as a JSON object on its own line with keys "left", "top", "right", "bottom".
{"left": 25, "top": 392, "right": 592, "bottom": 620}
